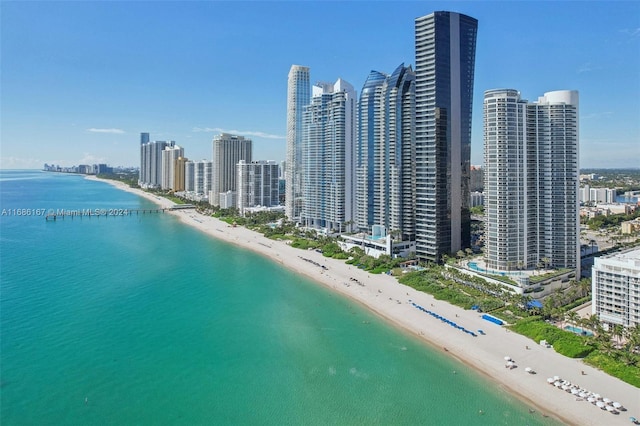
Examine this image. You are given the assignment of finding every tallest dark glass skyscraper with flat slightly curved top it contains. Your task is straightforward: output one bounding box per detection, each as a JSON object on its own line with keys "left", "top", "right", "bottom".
{"left": 415, "top": 12, "right": 478, "bottom": 262}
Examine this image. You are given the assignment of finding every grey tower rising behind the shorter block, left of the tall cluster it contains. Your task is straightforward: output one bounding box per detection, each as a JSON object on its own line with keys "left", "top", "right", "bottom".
{"left": 206, "top": 133, "right": 252, "bottom": 206}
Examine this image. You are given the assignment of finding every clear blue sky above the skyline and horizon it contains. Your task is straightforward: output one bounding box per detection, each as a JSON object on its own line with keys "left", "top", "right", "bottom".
{"left": 0, "top": 0, "right": 640, "bottom": 168}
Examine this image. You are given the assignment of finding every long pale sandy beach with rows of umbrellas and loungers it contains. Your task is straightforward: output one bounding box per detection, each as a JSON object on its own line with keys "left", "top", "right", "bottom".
{"left": 88, "top": 177, "right": 640, "bottom": 425}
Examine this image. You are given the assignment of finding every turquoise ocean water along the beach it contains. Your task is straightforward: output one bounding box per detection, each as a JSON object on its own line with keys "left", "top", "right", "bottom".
{"left": 0, "top": 171, "right": 555, "bottom": 426}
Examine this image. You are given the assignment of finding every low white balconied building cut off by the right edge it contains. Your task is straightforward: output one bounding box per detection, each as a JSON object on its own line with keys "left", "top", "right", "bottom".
{"left": 591, "top": 248, "right": 640, "bottom": 327}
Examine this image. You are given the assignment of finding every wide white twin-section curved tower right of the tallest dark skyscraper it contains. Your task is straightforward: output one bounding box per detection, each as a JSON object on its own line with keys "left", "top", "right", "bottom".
{"left": 484, "top": 89, "right": 580, "bottom": 276}
